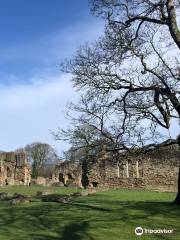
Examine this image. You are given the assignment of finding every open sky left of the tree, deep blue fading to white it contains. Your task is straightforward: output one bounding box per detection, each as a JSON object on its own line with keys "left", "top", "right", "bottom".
{"left": 0, "top": 0, "right": 103, "bottom": 153}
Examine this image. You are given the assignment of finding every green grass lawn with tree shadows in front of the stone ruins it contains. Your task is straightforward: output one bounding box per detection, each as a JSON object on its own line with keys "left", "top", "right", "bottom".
{"left": 0, "top": 186, "right": 180, "bottom": 240}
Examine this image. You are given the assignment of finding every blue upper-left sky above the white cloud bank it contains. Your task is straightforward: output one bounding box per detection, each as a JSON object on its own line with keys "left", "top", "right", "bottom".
{"left": 0, "top": 0, "right": 102, "bottom": 84}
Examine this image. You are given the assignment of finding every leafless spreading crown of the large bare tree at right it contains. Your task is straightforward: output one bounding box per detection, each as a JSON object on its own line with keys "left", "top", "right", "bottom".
{"left": 57, "top": 0, "right": 180, "bottom": 204}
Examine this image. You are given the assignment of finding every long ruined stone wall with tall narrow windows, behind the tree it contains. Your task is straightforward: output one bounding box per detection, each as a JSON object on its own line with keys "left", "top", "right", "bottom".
{"left": 55, "top": 144, "right": 180, "bottom": 192}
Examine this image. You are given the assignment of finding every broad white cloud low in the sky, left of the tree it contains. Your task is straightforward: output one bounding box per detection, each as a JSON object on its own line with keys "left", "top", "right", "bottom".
{"left": 0, "top": 74, "right": 77, "bottom": 155}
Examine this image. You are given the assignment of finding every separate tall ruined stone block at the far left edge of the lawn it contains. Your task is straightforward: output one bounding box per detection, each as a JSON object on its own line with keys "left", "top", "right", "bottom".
{"left": 0, "top": 152, "right": 31, "bottom": 186}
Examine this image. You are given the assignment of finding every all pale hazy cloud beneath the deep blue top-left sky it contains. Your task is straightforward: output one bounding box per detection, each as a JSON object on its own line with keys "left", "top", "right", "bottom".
{"left": 0, "top": 19, "right": 103, "bottom": 156}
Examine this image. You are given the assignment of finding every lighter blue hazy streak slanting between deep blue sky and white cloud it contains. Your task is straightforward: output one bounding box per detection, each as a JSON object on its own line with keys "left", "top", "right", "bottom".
{"left": 0, "top": 19, "right": 103, "bottom": 74}
